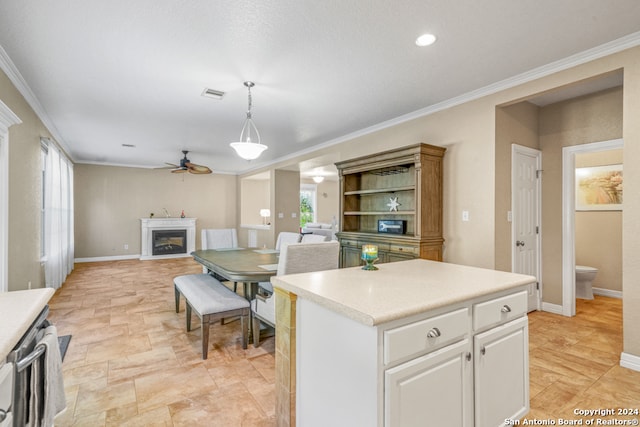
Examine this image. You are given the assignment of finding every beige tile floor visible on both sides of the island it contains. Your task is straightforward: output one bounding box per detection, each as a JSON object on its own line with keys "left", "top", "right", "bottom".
{"left": 49, "top": 258, "right": 640, "bottom": 427}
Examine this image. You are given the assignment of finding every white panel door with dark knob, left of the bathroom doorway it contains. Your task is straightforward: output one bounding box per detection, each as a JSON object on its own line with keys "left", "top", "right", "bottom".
{"left": 511, "top": 144, "right": 542, "bottom": 311}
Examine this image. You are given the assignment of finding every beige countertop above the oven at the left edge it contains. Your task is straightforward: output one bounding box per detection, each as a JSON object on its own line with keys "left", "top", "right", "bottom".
{"left": 0, "top": 288, "right": 55, "bottom": 359}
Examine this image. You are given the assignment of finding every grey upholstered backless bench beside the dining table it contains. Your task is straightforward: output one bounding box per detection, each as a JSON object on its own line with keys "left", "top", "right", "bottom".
{"left": 173, "top": 274, "right": 251, "bottom": 359}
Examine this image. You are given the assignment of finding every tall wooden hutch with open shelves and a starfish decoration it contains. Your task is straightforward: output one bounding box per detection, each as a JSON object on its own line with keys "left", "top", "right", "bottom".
{"left": 336, "top": 143, "right": 446, "bottom": 267}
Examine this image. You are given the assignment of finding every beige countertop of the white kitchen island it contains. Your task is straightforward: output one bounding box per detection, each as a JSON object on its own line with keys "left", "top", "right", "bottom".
{"left": 271, "top": 259, "right": 536, "bottom": 326}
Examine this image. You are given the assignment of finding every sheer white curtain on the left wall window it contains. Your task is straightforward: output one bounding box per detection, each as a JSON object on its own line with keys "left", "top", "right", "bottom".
{"left": 44, "top": 143, "right": 74, "bottom": 289}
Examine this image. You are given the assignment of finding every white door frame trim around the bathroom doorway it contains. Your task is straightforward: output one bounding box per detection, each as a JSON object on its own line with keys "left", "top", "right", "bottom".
{"left": 562, "top": 139, "right": 624, "bottom": 316}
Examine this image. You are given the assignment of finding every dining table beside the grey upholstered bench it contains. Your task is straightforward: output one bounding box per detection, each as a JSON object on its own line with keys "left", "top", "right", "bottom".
{"left": 191, "top": 248, "right": 279, "bottom": 301}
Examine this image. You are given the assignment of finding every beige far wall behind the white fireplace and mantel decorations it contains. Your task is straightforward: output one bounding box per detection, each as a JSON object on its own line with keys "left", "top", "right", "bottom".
{"left": 74, "top": 164, "right": 237, "bottom": 258}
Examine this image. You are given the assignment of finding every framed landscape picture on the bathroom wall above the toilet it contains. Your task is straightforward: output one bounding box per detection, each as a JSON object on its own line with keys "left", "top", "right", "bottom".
{"left": 576, "top": 165, "right": 622, "bottom": 211}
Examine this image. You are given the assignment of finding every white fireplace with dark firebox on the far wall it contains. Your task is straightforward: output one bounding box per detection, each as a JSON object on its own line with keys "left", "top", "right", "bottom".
{"left": 140, "top": 218, "right": 196, "bottom": 260}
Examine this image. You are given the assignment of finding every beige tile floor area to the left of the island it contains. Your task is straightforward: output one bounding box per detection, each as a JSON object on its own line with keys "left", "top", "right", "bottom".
{"left": 49, "top": 258, "right": 275, "bottom": 427}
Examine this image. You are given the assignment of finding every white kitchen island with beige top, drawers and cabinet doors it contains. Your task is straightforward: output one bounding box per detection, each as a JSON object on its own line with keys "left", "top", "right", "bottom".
{"left": 273, "top": 259, "right": 535, "bottom": 427}
